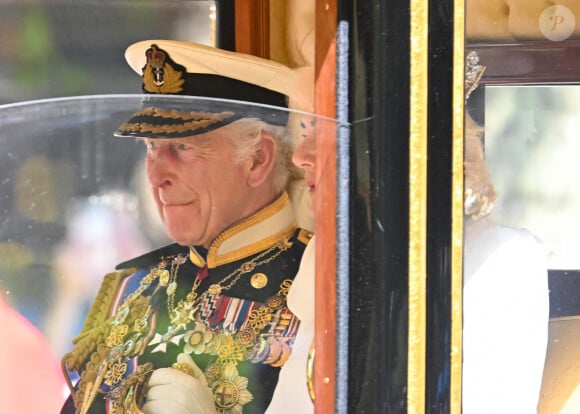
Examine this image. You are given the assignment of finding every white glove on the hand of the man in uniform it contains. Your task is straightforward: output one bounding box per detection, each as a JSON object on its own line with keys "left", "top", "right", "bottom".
{"left": 143, "top": 354, "right": 217, "bottom": 414}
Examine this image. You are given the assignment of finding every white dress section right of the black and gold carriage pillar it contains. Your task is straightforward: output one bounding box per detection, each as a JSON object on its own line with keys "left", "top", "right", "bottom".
{"left": 462, "top": 219, "right": 549, "bottom": 414}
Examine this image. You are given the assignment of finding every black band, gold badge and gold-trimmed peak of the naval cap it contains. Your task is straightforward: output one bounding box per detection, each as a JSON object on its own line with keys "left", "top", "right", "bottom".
{"left": 115, "top": 45, "right": 288, "bottom": 138}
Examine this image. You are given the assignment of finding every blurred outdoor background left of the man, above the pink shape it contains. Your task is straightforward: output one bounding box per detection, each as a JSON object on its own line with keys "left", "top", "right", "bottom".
{"left": 0, "top": 0, "right": 217, "bottom": 350}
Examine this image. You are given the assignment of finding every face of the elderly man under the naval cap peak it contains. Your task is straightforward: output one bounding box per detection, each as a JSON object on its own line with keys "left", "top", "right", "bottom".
{"left": 145, "top": 129, "right": 250, "bottom": 247}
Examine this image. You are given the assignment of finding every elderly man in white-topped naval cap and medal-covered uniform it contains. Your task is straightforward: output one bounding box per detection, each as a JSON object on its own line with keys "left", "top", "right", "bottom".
{"left": 62, "top": 40, "right": 312, "bottom": 414}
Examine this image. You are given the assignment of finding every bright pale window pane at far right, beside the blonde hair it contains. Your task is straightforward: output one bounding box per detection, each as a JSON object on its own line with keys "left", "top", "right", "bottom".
{"left": 485, "top": 85, "right": 580, "bottom": 269}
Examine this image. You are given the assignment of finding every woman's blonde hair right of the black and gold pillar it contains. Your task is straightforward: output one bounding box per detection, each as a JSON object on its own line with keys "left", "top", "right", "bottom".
{"left": 463, "top": 112, "right": 495, "bottom": 218}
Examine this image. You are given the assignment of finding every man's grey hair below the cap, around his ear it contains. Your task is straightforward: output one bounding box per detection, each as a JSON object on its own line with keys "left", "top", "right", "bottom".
{"left": 226, "top": 118, "right": 293, "bottom": 193}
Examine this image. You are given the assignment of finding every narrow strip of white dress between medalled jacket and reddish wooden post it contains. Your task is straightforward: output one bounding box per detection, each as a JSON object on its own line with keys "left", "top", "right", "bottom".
{"left": 266, "top": 237, "right": 315, "bottom": 414}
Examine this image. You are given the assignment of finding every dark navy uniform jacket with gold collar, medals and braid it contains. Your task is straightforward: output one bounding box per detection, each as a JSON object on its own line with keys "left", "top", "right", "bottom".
{"left": 62, "top": 194, "right": 311, "bottom": 414}
